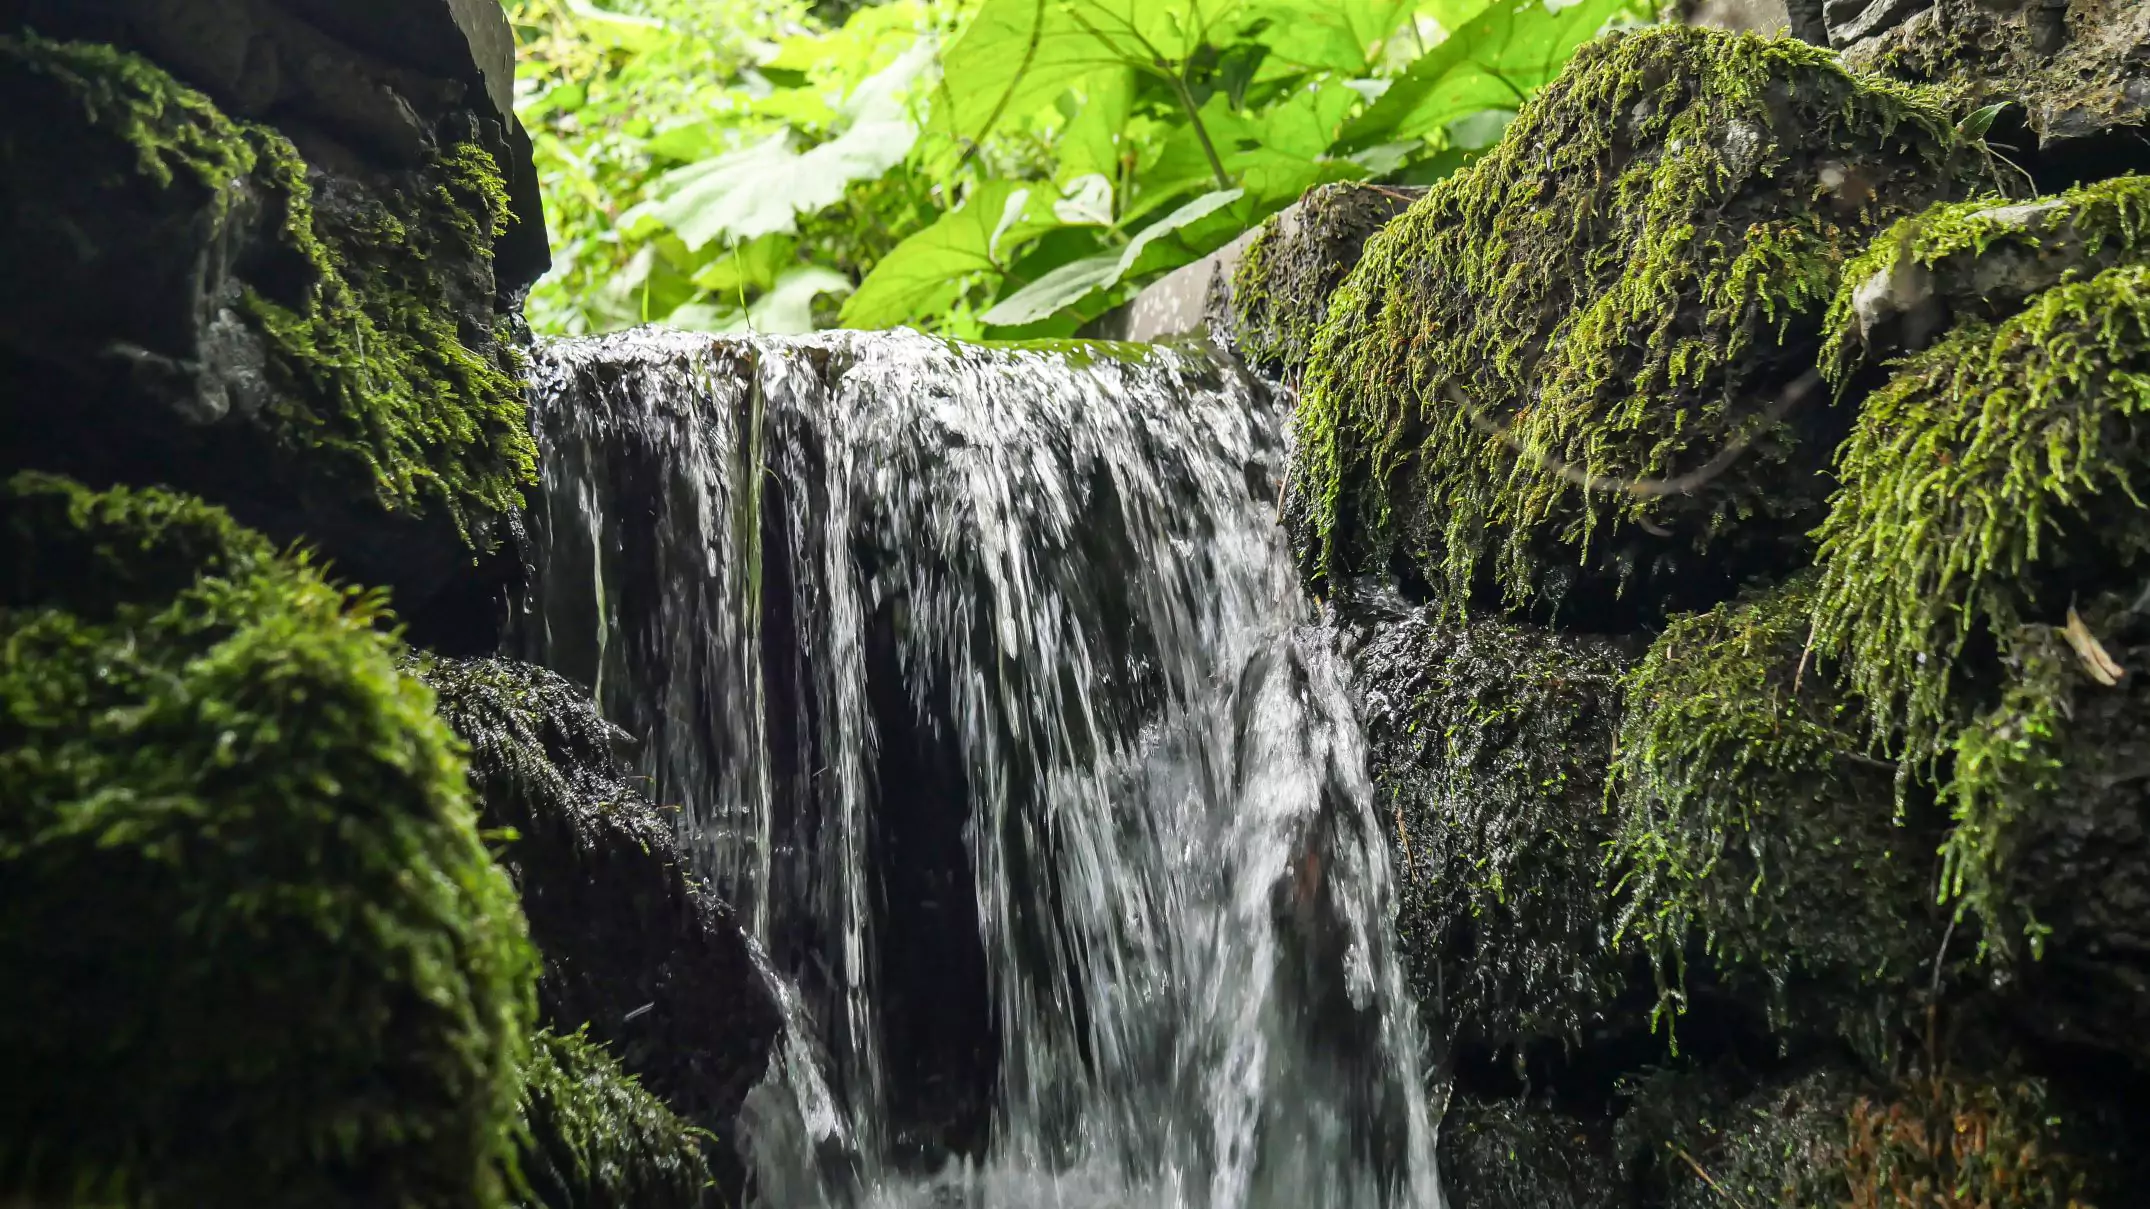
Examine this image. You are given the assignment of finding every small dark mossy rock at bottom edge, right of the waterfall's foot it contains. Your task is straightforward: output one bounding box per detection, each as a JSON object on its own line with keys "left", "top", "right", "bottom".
{"left": 1441, "top": 1101, "right": 1632, "bottom": 1209}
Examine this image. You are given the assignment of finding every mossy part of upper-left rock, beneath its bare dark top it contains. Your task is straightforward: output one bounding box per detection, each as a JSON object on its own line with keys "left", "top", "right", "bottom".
{"left": 0, "top": 32, "right": 535, "bottom": 623}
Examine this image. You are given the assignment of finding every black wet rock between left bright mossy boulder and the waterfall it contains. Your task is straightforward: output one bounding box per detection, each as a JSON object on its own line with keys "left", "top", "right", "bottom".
{"left": 421, "top": 658, "right": 780, "bottom": 1192}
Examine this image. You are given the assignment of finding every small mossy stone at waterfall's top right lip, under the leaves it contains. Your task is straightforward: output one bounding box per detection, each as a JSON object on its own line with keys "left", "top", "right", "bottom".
{"left": 1230, "top": 181, "right": 1425, "bottom": 381}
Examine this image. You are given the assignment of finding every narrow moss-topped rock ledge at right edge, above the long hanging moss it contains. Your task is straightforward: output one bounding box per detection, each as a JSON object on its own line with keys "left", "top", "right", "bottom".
{"left": 1823, "top": 174, "right": 2150, "bottom": 385}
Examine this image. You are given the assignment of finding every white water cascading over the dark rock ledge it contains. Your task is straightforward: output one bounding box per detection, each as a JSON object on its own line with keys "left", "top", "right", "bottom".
{"left": 527, "top": 331, "right": 1438, "bottom": 1209}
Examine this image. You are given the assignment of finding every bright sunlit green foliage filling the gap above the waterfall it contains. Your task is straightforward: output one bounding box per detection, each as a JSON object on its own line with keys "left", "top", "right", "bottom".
{"left": 510, "top": 0, "right": 1636, "bottom": 336}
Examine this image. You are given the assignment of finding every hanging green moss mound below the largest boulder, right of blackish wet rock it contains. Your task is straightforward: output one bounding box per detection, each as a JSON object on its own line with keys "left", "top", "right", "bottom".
{"left": 1606, "top": 574, "right": 1948, "bottom": 1037}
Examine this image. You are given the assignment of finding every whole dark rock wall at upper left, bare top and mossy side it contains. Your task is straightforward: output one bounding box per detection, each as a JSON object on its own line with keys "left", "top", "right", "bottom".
{"left": 0, "top": 0, "right": 546, "bottom": 648}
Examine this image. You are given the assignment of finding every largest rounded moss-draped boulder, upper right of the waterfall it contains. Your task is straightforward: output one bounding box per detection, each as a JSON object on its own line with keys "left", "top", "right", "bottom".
{"left": 1290, "top": 26, "right": 1987, "bottom": 628}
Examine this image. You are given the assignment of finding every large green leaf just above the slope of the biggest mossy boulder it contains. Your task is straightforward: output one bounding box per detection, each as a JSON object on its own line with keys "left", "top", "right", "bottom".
{"left": 1339, "top": 0, "right": 1632, "bottom": 151}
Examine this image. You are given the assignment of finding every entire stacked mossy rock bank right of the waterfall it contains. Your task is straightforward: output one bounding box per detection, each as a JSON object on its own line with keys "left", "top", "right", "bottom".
{"left": 1286, "top": 18, "right": 2150, "bottom": 1209}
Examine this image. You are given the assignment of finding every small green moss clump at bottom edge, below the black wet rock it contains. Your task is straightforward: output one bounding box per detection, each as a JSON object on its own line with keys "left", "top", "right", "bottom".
{"left": 520, "top": 1033, "right": 714, "bottom": 1209}
